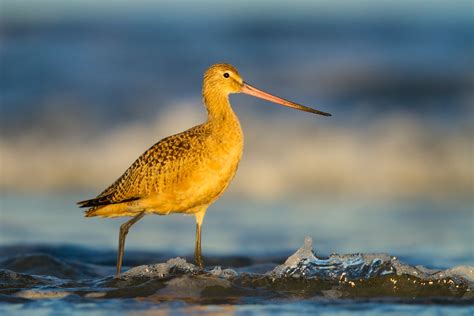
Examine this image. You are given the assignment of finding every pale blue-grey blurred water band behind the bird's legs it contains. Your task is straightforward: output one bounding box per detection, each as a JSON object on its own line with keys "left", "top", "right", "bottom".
{"left": 0, "top": 195, "right": 474, "bottom": 268}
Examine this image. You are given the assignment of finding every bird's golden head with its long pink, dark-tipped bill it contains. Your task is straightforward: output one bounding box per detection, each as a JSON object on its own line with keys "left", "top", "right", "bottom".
{"left": 203, "top": 64, "right": 331, "bottom": 116}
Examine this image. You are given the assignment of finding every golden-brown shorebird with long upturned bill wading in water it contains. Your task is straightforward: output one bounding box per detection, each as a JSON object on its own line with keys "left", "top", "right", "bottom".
{"left": 78, "top": 63, "right": 331, "bottom": 277}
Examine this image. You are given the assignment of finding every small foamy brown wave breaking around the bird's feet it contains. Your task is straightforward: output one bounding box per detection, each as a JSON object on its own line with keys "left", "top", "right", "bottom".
{"left": 0, "top": 237, "right": 474, "bottom": 304}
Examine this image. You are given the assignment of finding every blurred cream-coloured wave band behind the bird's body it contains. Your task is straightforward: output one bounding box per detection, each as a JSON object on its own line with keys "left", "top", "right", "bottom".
{"left": 0, "top": 101, "right": 474, "bottom": 200}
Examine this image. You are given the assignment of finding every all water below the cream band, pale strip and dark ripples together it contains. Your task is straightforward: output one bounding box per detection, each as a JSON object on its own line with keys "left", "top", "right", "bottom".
{"left": 0, "top": 194, "right": 474, "bottom": 315}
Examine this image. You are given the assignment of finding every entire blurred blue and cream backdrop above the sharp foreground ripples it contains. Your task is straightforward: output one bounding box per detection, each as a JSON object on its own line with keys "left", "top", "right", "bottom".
{"left": 0, "top": 0, "right": 474, "bottom": 267}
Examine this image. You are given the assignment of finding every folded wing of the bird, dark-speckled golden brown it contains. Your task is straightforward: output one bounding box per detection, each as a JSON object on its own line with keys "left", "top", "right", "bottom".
{"left": 77, "top": 126, "right": 207, "bottom": 207}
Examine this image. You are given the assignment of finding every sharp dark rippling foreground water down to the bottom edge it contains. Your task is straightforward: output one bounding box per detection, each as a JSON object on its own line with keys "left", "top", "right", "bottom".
{"left": 0, "top": 237, "right": 474, "bottom": 314}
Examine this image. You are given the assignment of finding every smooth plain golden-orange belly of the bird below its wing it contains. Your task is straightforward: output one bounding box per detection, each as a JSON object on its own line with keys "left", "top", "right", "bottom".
{"left": 148, "top": 143, "right": 242, "bottom": 214}
